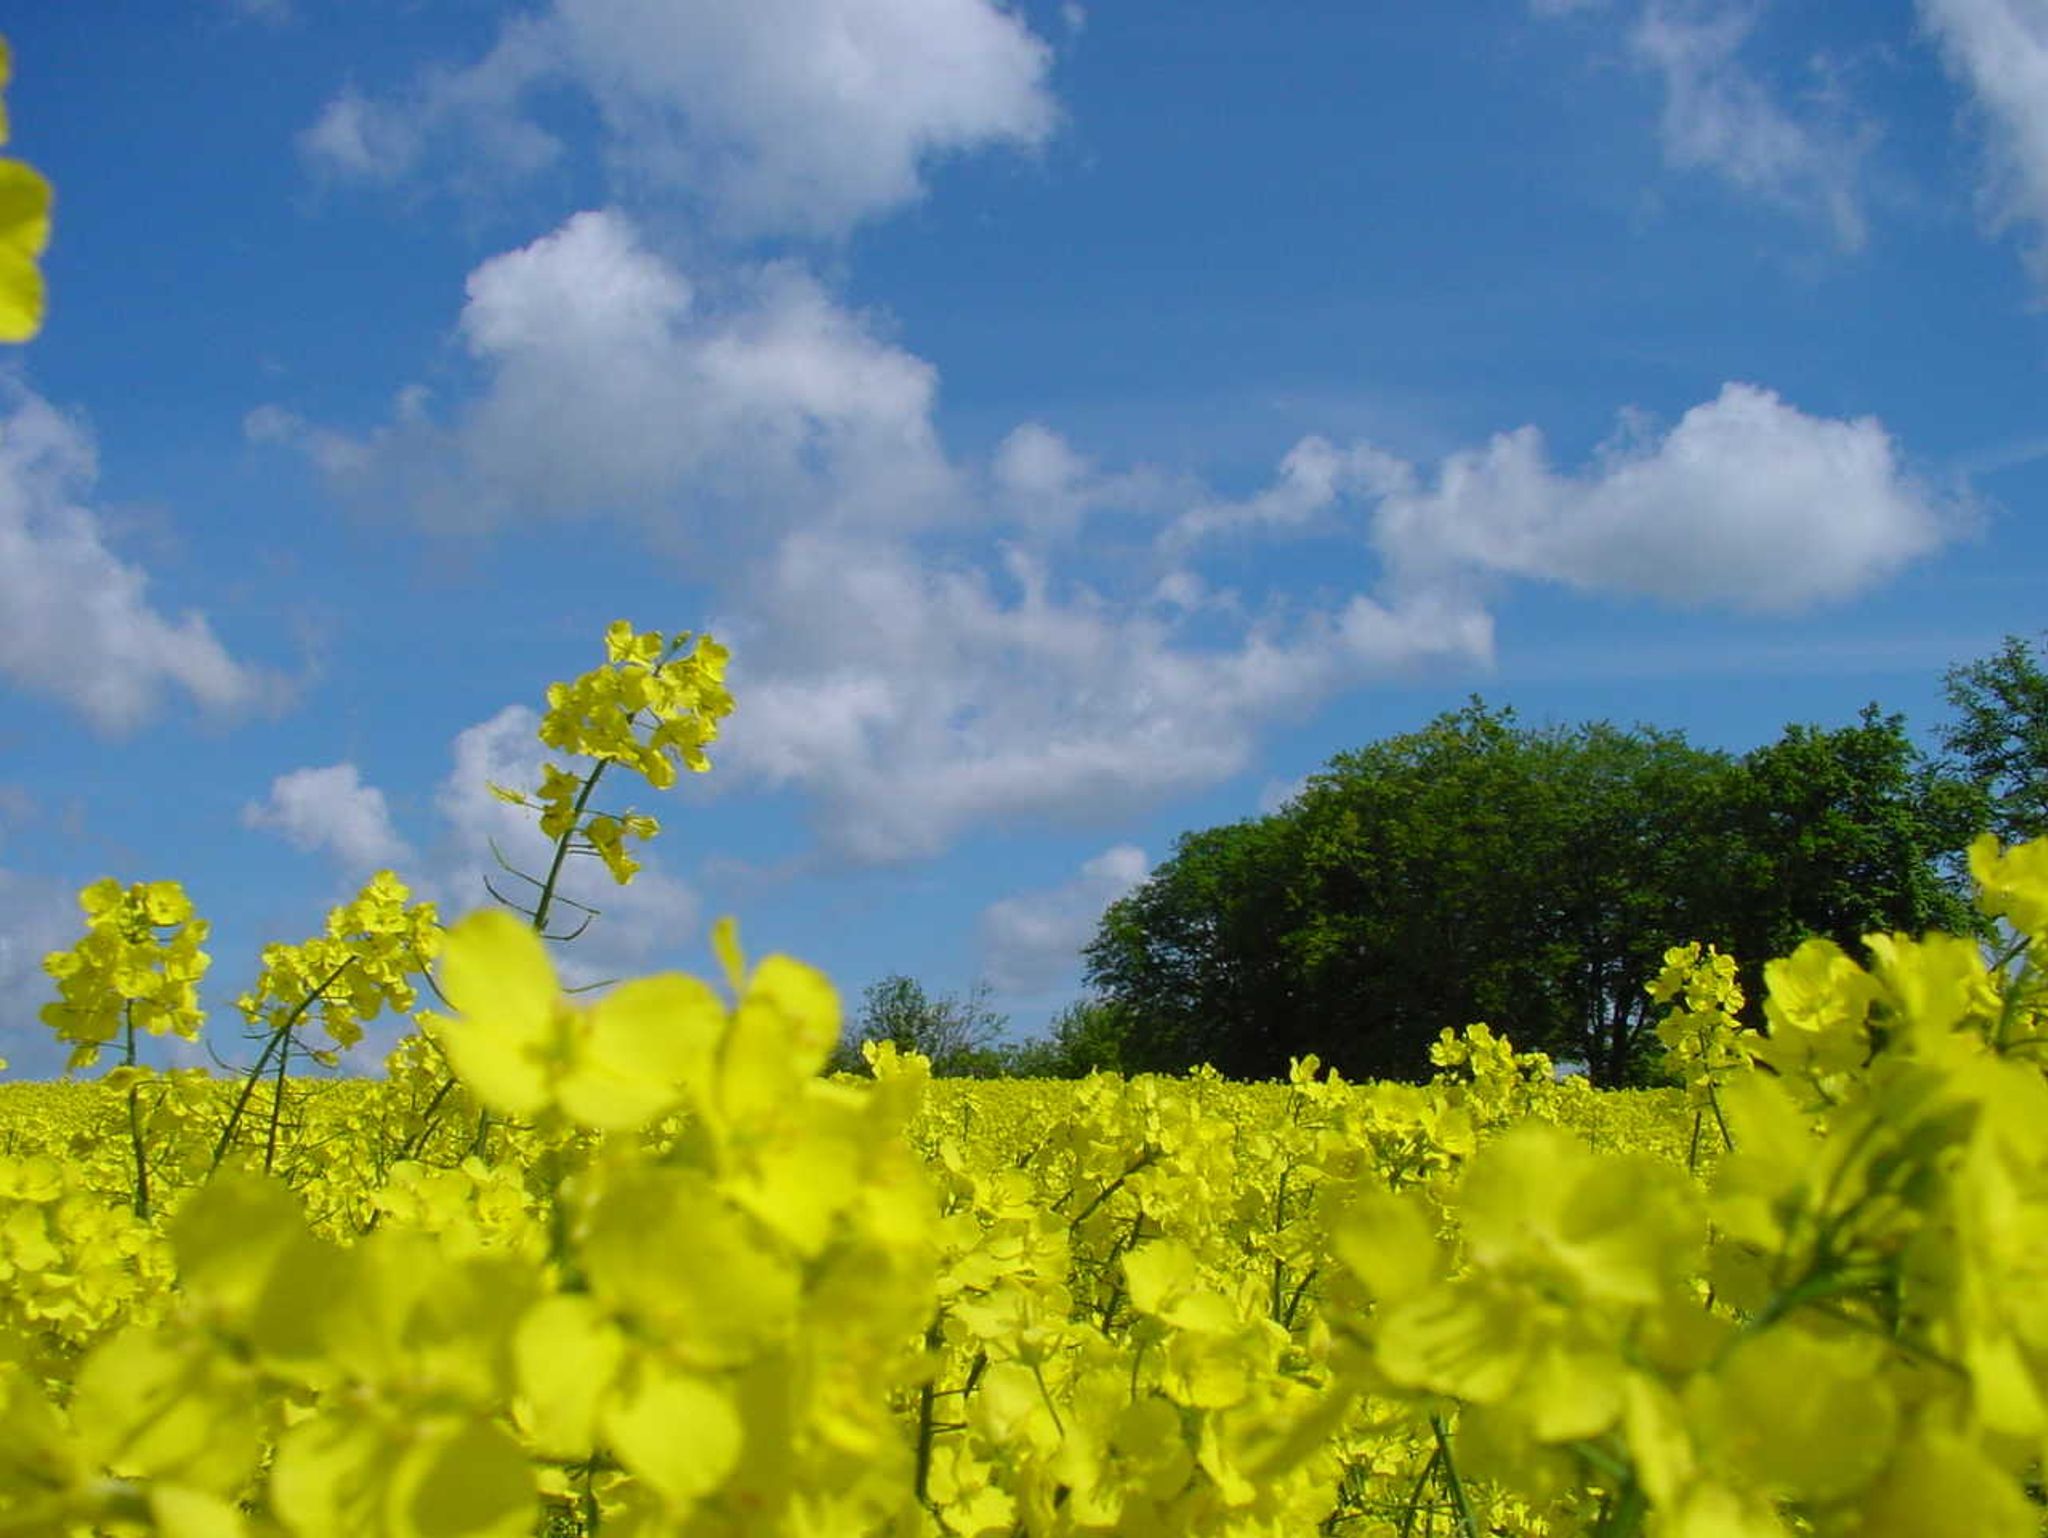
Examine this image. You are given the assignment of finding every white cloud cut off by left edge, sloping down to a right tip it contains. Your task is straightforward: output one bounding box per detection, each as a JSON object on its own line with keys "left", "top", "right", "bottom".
{"left": 0, "top": 385, "right": 289, "bottom": 735}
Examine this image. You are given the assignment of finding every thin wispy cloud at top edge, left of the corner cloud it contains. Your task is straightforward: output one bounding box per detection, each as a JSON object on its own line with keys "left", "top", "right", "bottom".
{"left": 1530, "top": 0, "right": 1870, "bottom": 250}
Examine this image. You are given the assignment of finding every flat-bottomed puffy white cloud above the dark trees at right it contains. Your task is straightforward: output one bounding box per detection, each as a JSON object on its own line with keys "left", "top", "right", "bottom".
{"left": 1374, "top": 383, "right": 1964, "bottom": 612}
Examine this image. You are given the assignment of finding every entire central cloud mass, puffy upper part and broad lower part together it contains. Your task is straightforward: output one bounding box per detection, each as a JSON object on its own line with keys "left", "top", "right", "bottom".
{"left": 268, "top": 213, "right": 1491, "bottom": 876}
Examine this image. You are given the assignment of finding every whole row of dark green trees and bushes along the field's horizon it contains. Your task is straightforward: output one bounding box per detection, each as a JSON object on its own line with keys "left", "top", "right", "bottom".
{"left": 834, "top": 637, "right": 2048, "bottom": 1085}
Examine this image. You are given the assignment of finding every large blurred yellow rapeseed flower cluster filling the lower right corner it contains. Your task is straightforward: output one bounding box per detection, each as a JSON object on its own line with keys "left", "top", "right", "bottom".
{"left": 1331, "top": 840, "right": 2048, "bottom": 1538}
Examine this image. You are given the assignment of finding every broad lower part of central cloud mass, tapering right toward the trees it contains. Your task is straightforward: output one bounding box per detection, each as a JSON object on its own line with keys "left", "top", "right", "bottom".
{"left": 719, "top": 532, "right": 1493, "bottom": 862}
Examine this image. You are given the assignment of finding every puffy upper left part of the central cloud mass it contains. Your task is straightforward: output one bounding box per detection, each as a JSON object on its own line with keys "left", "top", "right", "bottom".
{"left": 268, "top": 211, "right": 956, "bottom": 559}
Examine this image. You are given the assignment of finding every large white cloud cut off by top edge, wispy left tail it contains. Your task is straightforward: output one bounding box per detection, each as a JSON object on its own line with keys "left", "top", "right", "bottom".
{"left": 301, "top": 0, "right": 1057, "bottom": 236}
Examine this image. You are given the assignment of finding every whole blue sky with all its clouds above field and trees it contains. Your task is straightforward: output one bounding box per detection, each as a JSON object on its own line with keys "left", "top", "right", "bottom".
{"left": 0, "top": 0, "right": 2048, "bottom": 1073}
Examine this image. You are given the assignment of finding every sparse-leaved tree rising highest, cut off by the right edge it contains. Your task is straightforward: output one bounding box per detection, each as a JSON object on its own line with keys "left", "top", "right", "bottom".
{"left": 1939, "top": 633, "right": 2048, "bottom": 844}
